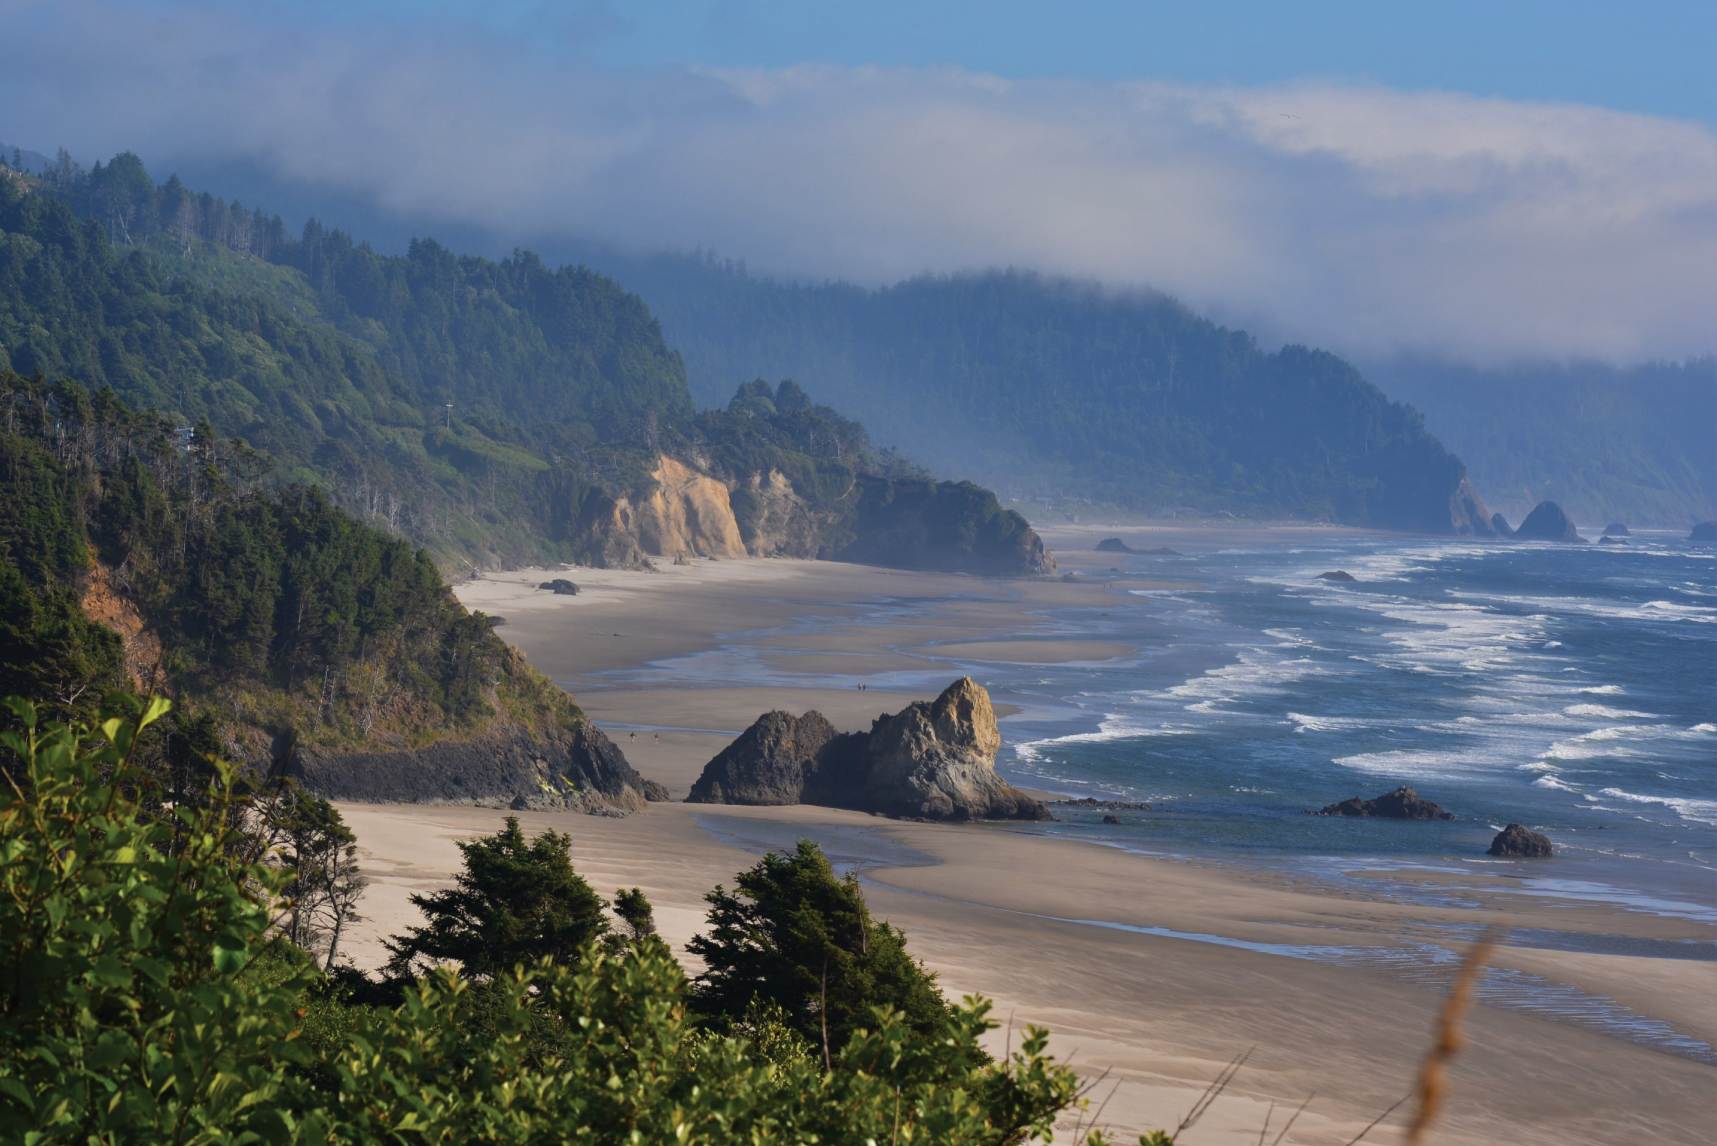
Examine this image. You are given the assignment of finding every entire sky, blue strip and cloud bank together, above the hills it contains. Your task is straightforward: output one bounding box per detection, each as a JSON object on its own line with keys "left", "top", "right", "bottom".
{"left": 0, "top": 0, "right": 1717, "bottom": 363}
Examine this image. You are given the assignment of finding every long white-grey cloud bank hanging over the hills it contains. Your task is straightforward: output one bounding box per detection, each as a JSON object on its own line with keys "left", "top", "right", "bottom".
{"left": 0, "top": 0, "right": 1717, "bottom": 361}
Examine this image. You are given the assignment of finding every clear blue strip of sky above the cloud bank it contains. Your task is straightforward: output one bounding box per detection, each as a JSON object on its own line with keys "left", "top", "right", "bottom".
{"left": 338, "top": 0, "right": 1717, "bottom": 122}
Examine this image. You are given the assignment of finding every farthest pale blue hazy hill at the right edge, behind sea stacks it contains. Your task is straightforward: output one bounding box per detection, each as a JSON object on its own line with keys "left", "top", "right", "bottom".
{"left": 1370, "top": 356, "right": 1717, "bottom": 529}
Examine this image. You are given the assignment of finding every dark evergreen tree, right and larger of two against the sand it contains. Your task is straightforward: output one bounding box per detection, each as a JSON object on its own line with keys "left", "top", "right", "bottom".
{"left": 687, "top": 840, "right": 950, "bottom": 1048}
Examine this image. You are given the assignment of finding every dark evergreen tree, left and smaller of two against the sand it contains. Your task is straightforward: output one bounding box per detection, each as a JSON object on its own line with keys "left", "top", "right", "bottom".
{"left": 388, "top": 816, "right": 608, "bottom": 979}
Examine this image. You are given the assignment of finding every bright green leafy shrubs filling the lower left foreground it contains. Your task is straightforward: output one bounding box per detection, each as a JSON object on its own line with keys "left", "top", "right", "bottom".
{"left": 0, "top": 703, "right": 1077, "bottom": 1146}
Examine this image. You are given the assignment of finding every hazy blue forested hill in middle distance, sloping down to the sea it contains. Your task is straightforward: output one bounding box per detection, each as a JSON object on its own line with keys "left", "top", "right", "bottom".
{"left": 576, "top": 256, "right": 1490, "bottom": 533}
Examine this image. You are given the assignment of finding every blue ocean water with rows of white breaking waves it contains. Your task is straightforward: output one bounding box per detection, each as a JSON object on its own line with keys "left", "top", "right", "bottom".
{"left": 974, "top": 533, "right": 1717, "bottom": 921}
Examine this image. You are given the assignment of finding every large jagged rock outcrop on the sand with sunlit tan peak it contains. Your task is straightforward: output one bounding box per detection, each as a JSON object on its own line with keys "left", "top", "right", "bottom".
{"left": 687, "top": 677, "right": 1051, "bottom": 820}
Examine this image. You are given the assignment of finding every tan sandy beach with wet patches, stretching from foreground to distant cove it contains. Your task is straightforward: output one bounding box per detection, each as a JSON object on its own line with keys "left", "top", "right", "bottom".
{"left": 327, "top": 526, "right": 1717, "bottom": 1146}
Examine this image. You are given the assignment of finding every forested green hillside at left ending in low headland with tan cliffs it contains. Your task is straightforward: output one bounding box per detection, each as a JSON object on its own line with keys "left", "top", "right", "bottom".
{"left": 0, "top": 155, "right": 1047, "bottom": 572}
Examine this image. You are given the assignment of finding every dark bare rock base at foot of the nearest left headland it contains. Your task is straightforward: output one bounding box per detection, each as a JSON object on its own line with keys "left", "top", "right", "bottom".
{"left": 287, "top": 720, "right": 668, "bottom": 814}
